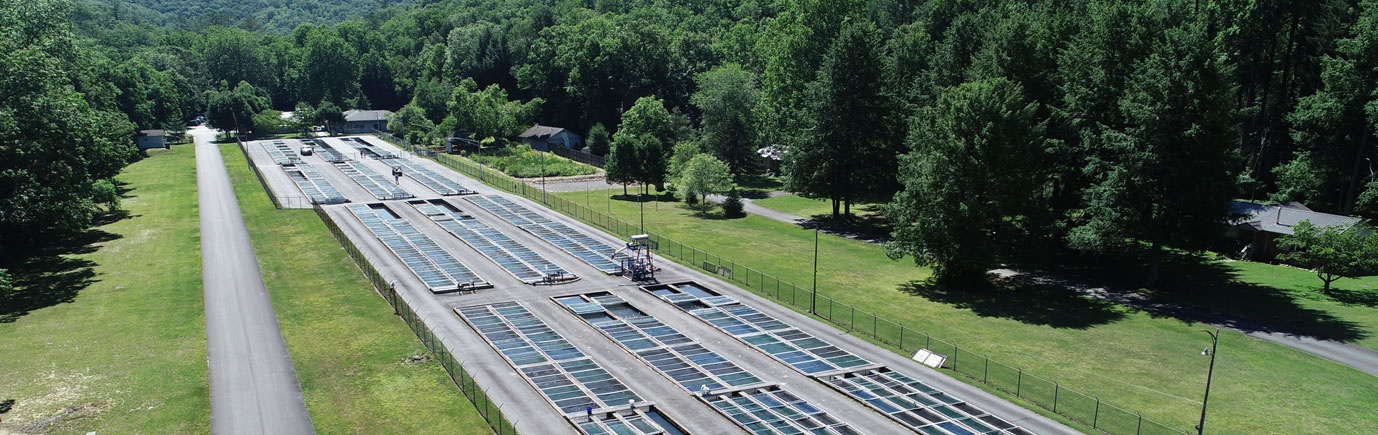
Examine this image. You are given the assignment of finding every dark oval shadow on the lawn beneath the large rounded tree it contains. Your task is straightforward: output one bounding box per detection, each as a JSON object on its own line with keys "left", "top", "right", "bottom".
{"left": 900, "top": 278, "right": 1124, "bottom": 329}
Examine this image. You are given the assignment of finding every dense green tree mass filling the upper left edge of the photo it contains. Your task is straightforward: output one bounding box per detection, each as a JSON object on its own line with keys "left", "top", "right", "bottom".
{"left": 0, "top": 1, "right": 138, "bottom": 253}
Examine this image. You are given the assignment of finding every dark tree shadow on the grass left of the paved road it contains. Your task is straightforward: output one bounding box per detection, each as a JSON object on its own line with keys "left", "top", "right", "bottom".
{"left": 0, "top": 207, "right": 134, "bottom": 323}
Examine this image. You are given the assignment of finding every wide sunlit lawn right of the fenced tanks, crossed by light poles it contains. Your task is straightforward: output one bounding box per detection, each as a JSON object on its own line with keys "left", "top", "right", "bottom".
{"left": 553, "top": 189, "right": 1378, "bottom": 434}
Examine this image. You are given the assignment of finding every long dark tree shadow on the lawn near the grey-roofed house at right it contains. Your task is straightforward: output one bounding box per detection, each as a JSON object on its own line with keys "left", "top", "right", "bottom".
{"left": 1019, "top": 252, "right": 1378, "bottom": 341}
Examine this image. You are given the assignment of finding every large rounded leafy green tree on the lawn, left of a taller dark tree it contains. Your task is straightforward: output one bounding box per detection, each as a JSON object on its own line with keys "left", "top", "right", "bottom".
{"left": 885, "top": 78, "right": 1046, "bottom": 281}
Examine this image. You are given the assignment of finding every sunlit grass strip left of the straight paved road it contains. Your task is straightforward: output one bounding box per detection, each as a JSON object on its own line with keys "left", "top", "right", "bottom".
{"left": 0, "top": 147, "right": 209, "bottom": 434}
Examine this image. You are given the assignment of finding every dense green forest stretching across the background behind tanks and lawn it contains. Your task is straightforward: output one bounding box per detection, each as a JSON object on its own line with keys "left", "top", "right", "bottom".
{"left": 11, "top": 0, "right": 1378, "bottom": 284}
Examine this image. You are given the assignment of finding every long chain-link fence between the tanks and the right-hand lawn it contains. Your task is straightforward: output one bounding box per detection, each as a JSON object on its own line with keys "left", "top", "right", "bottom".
{"left": 435, "top": 154, "right": 1188, "bottom": 434}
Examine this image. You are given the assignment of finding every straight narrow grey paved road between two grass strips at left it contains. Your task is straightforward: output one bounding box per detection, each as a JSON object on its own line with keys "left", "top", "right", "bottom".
{"left": 187, "top": 127, "right": 314, "bottom": 435}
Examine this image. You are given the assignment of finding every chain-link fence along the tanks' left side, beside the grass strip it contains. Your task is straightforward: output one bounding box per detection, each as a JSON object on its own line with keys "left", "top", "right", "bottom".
{"left": 314, "top": 206, "right": 517, "bottom": 435}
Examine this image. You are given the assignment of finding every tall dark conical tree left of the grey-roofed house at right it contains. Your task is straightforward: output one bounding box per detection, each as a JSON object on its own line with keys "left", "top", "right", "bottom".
{"left": 1069, "top": 23, "right": 1237, "bottom": 285}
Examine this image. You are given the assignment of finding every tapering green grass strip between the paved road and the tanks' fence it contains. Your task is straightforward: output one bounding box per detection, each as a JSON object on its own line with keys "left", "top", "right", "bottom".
{"left": 220, "top": 145, "right": 492, "bottom": 434}
